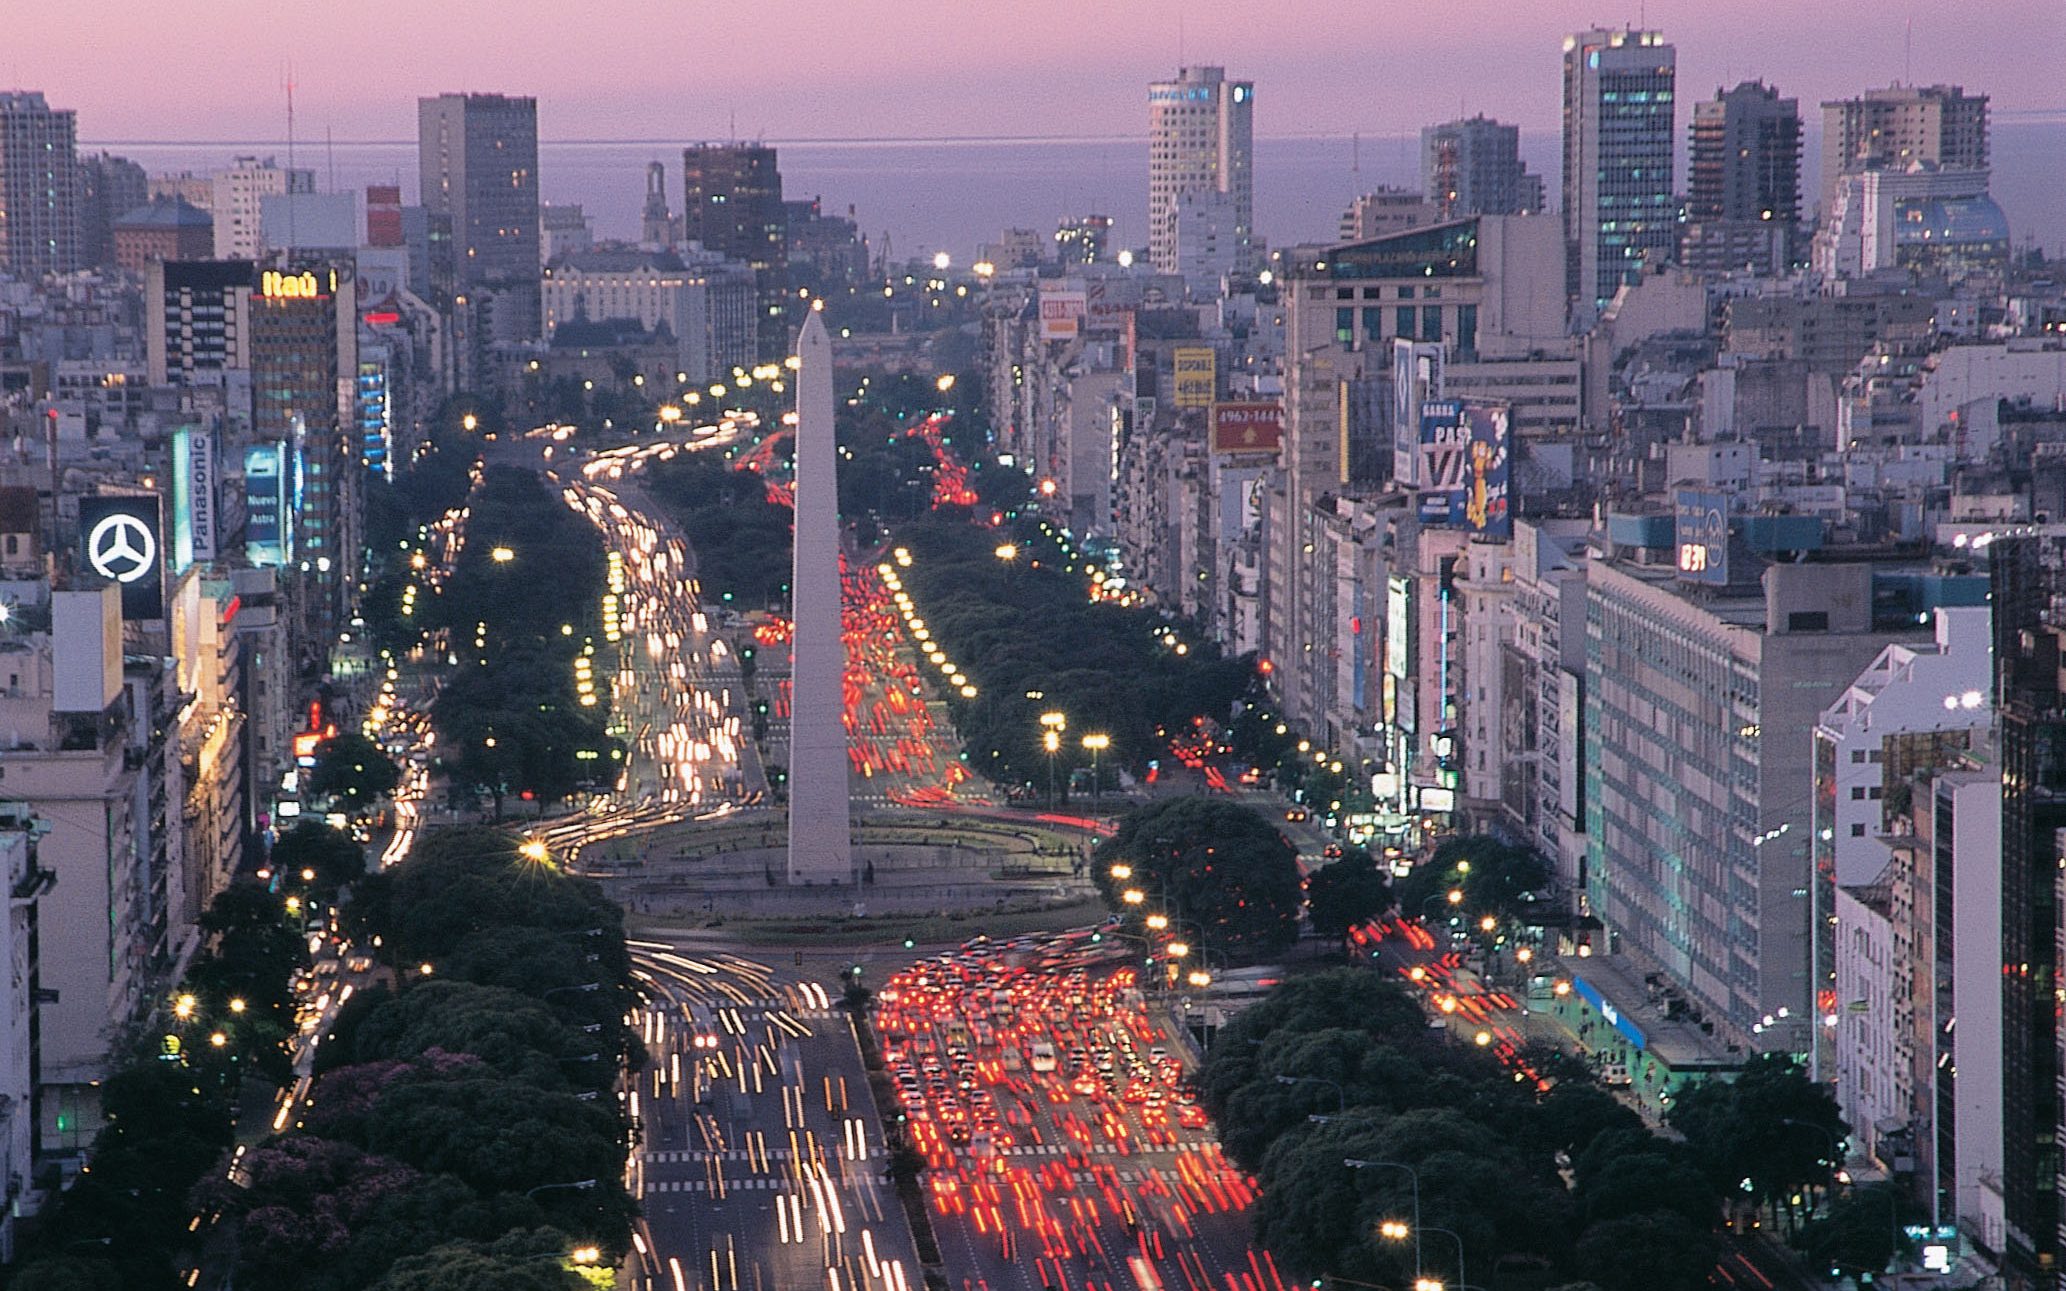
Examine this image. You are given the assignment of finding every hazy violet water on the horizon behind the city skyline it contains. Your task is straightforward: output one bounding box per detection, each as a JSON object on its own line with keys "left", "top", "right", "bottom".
{"left": 100, "top": 114, "right": 2066, "bottom": 258}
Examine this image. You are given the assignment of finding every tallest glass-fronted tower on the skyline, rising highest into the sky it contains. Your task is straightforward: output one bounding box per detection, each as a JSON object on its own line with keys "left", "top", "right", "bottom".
{"left": 1564, "top": 29, "right": 1678, "bottom": 314}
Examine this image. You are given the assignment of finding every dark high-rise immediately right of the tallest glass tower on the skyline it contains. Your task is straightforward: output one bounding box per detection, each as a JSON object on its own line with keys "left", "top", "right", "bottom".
{"left": 1682, "top": 81, "right": 1802, "bottom": 269}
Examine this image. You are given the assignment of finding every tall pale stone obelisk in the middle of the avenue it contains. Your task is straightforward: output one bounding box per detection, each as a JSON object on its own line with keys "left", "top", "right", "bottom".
{"left": 789, "top": 310, "right": 853, "bottom": 884}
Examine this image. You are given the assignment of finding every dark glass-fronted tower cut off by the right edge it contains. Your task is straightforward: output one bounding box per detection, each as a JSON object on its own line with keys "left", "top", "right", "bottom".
{"left": 1990, "top": 529, "right": 2066, "bottom": 1287}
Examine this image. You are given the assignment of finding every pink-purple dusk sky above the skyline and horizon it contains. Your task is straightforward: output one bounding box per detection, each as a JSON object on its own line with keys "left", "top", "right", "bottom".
{"left": 24, "top": 0, "right": 2066, "bottom": 143}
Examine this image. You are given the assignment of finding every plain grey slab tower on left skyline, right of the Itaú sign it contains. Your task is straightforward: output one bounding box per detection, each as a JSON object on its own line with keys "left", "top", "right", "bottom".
{"left": 415, "top": 95, "right": 539, "bottom": 343}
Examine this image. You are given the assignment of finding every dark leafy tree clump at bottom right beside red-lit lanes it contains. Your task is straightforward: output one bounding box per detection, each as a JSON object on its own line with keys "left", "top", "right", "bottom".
{"left": 1200, "top": 967, "right": 1901, "bottom": 1291}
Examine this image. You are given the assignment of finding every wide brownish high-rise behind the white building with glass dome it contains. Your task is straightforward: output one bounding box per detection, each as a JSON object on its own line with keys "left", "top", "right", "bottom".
{"left": 1822, "top": 85, "right": 1987, "bottom": 219}
